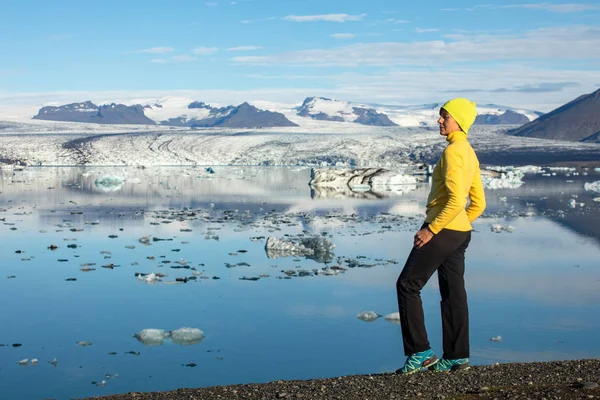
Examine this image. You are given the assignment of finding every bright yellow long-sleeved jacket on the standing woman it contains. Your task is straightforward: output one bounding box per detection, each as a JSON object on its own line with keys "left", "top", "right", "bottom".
{"left": 425, "top": 131, "right": 485, "bottom": 234}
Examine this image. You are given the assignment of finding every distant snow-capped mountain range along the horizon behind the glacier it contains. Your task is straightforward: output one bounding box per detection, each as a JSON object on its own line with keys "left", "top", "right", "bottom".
{"left": 33, "top": 96, "right": 542, "bottom": 128}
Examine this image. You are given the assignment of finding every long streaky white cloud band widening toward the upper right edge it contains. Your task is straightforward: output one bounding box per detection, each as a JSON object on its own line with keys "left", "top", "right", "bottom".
{"left": 233, "top": 26, "right": 600, "bottom": 67}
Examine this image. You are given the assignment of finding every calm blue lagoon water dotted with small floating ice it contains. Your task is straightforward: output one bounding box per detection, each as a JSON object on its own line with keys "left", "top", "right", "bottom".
{"left": 0, "top": 167, "right": 600, "bottom": 399}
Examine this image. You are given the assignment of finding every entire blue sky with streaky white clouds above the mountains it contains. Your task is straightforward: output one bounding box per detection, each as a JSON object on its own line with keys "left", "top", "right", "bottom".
{"left": 0, "top": 0, "right": 600, "bottom": 111}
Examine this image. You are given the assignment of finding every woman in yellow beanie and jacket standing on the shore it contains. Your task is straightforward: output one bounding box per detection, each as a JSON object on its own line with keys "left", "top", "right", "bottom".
{"left": 396, "top": 98, "right": 485, "bottom": 374}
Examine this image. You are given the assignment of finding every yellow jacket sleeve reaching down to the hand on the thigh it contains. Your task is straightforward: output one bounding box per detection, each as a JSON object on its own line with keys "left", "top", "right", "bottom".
{"left": 429, "top": 146, "right": 467, "bottom": 234}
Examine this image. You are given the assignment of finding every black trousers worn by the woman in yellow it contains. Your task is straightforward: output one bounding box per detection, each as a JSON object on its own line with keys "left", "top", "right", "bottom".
{"left": 396, "top": 225, "right": 471, "bottom": 359}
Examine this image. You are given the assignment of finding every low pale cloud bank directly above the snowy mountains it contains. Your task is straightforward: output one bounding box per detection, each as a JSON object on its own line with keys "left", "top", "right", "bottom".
{"left": 0, "top": 63, "right": 600, "bottom": 115}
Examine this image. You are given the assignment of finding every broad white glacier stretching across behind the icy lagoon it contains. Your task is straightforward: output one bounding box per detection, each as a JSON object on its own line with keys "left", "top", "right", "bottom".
{"left": 0, "top": 117, "right": 600, "bottom": 170}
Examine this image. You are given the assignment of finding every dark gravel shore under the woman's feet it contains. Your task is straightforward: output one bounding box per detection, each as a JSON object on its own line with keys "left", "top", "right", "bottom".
{"left": 85, "top": 359, "right": 600, "bottom": 400}
